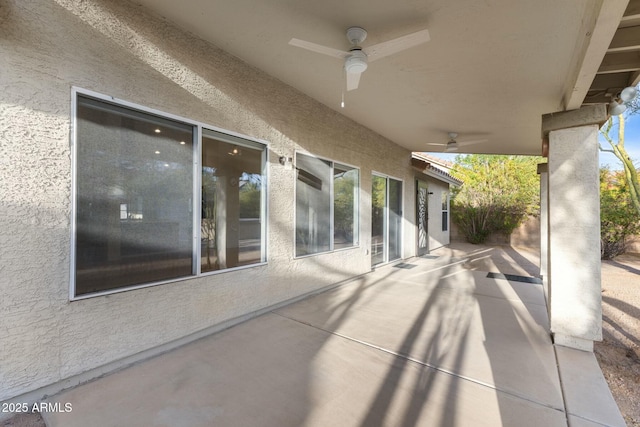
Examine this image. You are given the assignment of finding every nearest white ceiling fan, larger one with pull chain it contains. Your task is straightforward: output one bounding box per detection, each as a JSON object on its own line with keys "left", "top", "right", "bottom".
{"left": 289, "top": 27, "right": 430, "bottom": 91}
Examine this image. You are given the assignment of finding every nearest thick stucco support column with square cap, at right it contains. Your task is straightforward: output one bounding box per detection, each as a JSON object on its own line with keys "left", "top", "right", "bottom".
{"left": 542, "top": 106, "right": 607, "bottom": 351}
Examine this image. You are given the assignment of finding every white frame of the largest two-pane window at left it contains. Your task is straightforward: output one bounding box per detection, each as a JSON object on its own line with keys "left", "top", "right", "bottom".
{"left": 69, "top": 86, "right": 269, "bottom": 302}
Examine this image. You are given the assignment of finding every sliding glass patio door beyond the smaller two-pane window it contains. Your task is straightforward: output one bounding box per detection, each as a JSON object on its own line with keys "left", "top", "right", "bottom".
{"left": 371, "top": 175, "right": 402, "bottom": 266}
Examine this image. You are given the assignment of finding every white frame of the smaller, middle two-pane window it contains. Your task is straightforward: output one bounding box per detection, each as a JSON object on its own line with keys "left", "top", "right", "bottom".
{"left": 293, "top": 150, "right": 362, "bottom": 259}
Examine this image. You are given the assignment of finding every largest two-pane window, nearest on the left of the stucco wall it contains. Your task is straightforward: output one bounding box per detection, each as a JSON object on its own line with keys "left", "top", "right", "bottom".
{"left": 71, "top": 92, "right": 266, "bottom": 298}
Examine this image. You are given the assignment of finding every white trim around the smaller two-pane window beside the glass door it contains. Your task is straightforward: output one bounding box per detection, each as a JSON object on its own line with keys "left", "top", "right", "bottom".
{"left": 292, "top": 150, "right": 362, "bottom": 259}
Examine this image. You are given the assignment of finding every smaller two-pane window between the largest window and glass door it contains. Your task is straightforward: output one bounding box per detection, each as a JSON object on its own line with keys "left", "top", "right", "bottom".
{"left": 296, "top": 153, "right": 359, "bottom": 256}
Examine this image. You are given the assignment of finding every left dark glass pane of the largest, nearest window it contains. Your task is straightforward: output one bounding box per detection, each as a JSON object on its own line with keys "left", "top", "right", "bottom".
{"left": 75, "top": 96, "right": 193, "bottom": 295}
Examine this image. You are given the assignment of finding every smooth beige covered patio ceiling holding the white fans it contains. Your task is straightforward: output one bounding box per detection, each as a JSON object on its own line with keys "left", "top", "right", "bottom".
{"left": 132, "top": 0, "right": 640, "bottom": 155}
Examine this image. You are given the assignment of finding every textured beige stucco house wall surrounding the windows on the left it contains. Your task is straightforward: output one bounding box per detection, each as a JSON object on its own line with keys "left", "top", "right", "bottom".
{"left": 0, "top": 0, "right": 415, "bottom": 401}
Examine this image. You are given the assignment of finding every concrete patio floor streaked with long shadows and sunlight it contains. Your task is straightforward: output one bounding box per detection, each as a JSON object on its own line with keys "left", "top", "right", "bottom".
{"left": 43, "top": 245, "right": 625, "bottom": 427}
